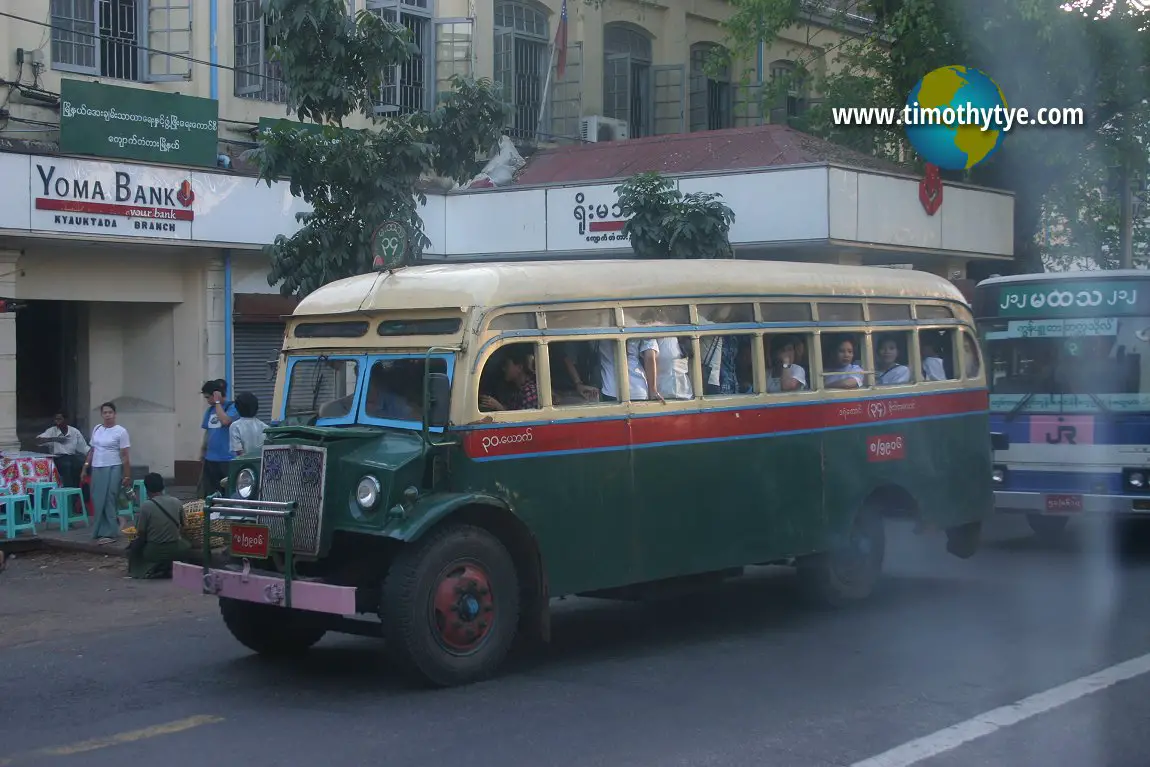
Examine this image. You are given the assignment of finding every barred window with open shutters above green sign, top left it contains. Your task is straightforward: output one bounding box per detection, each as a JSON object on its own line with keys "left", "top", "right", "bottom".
{"left": 49, "top": 0, "right": 192, "bottom": 82}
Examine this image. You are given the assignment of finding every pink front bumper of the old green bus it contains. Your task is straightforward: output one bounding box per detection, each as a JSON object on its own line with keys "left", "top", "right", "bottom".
{"left": 171, "top": 562, "right": 355, "bottom": 615}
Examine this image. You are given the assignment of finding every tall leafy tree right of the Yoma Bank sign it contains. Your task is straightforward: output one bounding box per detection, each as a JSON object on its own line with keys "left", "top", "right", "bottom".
{"left": 250, "top": 0, "right": 507, "bottom": 297}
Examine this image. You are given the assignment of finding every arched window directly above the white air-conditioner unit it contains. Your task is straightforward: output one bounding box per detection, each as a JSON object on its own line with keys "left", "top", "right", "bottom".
{"left": 603, "top": 24, "right": 653, "bottom": 138}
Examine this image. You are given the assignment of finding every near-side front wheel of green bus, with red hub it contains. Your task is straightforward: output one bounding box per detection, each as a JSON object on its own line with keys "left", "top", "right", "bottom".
{"left": 380, "top": 524, "right": 520, "bottom": 687}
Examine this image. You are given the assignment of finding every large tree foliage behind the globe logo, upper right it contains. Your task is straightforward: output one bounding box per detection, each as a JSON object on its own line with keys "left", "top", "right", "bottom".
{"left": 726, "top": 0, "right": 1150, "bottom": 271}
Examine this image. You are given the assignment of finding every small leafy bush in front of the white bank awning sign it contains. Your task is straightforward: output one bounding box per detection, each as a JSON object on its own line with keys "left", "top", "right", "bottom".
{"left": 615, "top": 172, "right": 735, "bottom": 259}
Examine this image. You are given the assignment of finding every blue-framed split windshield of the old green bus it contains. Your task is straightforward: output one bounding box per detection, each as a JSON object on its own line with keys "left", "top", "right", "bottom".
{"left": 284, "top": 354, "right": 449, "bottom": 429}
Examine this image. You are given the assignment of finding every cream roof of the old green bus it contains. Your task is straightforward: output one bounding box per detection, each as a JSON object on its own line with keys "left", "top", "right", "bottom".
{"left": 294, "top": 259, "right": 966, "bottom": 316}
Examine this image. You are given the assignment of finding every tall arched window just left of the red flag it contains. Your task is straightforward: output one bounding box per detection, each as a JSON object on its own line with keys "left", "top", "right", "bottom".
{"left": 495, "top": 0, "right": 551, "bottom": 138}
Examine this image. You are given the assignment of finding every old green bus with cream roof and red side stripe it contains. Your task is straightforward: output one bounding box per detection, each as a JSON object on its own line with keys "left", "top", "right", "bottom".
{"left": 175, "top": 260, "right": 994, "bottom": 685}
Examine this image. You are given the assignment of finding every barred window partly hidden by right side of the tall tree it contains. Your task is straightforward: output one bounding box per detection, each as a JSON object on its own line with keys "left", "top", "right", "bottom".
{"left": 367, "top": 0, "right": 435, "bottom": 115}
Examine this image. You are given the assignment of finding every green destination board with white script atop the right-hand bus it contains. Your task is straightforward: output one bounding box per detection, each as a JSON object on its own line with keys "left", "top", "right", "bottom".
{"left": 979, "top": 279, "right": 1150, "bottom": 317}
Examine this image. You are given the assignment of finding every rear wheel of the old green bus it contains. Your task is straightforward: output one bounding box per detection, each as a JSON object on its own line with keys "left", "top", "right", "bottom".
{"left": 797, "top": 507, "right": 887, "bottom": 607}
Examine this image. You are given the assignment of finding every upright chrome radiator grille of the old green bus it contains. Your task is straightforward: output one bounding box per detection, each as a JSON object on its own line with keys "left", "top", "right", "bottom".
{"left": 260, "top": 445, "right": 328, "bottom": 557}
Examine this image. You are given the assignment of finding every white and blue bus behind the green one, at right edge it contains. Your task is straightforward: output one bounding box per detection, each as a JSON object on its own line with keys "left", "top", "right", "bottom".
{"left": 974, "top": 270, "right": 1150, "bottom": 539}
